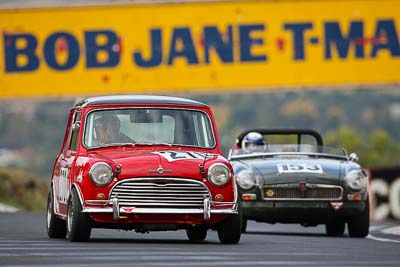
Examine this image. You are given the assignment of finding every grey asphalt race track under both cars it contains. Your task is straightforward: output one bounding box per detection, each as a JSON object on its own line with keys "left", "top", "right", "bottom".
{"left": 0, "top": 213, "right": 400, "bottom": 267}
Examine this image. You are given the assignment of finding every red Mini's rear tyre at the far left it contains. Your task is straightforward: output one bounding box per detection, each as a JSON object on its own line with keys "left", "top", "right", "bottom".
{"left": 46, "top": 190, "right": 67, "bottom": 238}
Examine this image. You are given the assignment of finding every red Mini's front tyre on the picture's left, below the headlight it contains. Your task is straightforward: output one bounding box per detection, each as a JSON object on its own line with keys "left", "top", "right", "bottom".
{"left": 67, "top": 189, "right": 92, "bottom": 242}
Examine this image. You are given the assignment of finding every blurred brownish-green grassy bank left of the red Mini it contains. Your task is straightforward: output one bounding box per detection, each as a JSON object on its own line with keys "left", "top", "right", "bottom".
{"left": 0, "top": 168, "right": 49, "bottom": 211}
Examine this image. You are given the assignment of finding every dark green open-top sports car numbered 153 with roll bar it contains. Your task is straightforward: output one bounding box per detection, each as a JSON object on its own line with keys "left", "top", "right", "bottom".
{"left": 229, "top": 129, "right": 369, "bottom": 237}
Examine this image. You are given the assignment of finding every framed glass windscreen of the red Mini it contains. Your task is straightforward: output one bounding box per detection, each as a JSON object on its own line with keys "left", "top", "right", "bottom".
{"left": 84, "top": 108, "right": 215, "bottom": 148}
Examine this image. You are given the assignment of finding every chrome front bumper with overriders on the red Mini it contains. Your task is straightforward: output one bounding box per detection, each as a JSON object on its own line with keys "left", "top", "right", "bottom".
{"left": 82, "top": 198, "right": 238, "bottom": 222}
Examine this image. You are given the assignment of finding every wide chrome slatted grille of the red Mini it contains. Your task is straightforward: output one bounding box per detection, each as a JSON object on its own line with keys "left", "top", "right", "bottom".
{"left": 110, "top": 178, "right": 210, "bottom": 208}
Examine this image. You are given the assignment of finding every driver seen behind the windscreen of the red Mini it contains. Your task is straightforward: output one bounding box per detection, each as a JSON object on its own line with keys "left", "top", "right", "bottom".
{"left": 94, "top": 114, "right": 132, "bottom": 145}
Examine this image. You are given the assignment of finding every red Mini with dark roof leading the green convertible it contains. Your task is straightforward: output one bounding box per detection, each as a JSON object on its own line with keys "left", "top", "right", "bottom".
{"left": 46, "top": 95, "right": 241, "bottom": 244}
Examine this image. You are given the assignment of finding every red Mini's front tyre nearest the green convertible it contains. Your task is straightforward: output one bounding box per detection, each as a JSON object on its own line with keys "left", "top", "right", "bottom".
{"left": 218, "top": 205, "right": 242, "bottom": 244}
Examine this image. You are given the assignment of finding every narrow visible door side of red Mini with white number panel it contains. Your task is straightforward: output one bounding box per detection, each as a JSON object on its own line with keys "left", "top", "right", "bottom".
{"left": 53, "top": 110, "right": 82, "bottom": 216}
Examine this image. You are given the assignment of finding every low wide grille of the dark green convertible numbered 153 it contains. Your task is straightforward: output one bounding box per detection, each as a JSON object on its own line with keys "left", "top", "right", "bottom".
{"left": 264, "top": 184, "right": 343, "bottom": 200}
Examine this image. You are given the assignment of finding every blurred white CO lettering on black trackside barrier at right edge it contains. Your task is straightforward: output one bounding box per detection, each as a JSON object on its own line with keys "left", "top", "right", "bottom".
{"left": 370, "top": 177, "right": 400, "bottom": 221}
